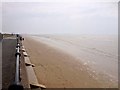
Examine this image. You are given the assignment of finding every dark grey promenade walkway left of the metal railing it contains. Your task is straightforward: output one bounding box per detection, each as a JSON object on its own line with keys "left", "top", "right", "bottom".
{"left": 2, "top": 39, "right": 17, "bottom": 88}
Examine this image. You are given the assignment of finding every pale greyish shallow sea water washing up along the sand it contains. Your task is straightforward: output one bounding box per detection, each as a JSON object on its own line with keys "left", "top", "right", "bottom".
{"left": 29, "top": 35, "right": 118, "bottom": 82}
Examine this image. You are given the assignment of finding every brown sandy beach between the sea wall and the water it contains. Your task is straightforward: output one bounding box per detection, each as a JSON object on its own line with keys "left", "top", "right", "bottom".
{"left": 23, "top": 37, "right": 117, "bottom": 88}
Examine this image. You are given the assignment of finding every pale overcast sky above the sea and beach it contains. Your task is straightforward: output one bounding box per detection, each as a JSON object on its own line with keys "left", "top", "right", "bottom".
{"left": 0, "top": 0, "right": 118, "bottom": 34}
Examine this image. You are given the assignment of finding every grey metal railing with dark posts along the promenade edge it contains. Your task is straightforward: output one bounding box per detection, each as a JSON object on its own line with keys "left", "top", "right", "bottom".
{"left": 8, "top": 35, "right": 24, "bottom": 90}
